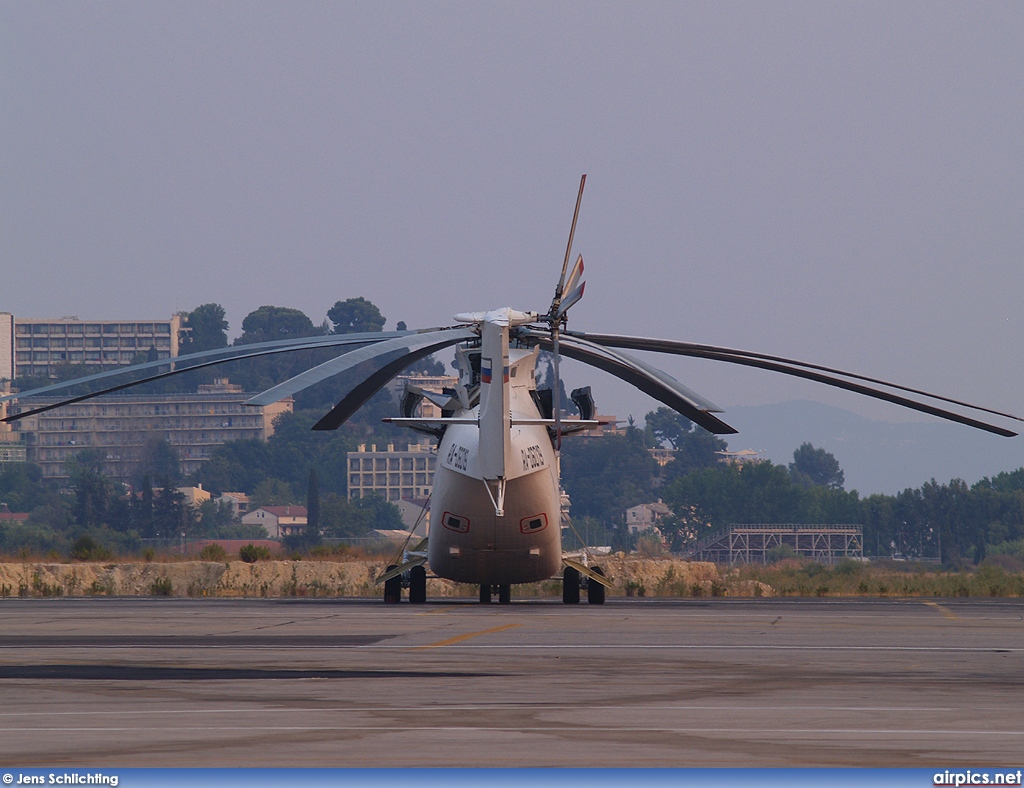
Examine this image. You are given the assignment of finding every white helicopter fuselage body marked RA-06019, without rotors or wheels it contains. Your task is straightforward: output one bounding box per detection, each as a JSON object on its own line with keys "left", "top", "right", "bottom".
{"left": 427, "top": 346, "right": 562, "bottom": 584}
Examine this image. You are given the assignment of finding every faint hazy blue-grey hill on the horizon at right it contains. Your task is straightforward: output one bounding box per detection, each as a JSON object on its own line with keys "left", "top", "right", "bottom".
{"left": 724, "top": 400, "right": 1024, "bottom": 495}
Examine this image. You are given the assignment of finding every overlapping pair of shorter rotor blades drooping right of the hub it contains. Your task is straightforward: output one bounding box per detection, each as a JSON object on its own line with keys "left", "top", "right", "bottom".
{"left": 523, "top": 331, "right": 736, "bottom": 435}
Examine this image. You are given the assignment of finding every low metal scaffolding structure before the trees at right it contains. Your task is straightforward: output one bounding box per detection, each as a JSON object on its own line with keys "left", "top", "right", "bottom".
{"left": 690, "top": 523, "right": 864, "bottom": 566}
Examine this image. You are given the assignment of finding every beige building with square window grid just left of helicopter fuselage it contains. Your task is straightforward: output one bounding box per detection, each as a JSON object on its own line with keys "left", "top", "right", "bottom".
{"left": 348, "top": 443, "right": 437, "bottom": 501}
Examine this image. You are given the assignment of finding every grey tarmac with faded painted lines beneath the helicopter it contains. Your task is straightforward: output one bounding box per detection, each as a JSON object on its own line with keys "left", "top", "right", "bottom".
{"left": 0, "top": 598, "right": 1024, "bottom": 768}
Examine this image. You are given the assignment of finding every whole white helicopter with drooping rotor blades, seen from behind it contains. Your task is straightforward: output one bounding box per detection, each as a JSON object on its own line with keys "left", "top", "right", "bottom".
{"left": 0, "top": 175, "right": 1024, "bottom": 604}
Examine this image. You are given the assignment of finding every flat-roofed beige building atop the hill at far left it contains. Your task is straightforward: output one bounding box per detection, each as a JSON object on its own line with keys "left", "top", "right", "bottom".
{"left": 0, "top": 312, "right": 181, "bottom": 380}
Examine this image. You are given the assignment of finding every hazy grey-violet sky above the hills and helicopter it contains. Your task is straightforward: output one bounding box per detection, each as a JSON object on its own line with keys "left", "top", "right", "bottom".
{"left": 0, "top": 1, "right": 1024, "bottom": 448}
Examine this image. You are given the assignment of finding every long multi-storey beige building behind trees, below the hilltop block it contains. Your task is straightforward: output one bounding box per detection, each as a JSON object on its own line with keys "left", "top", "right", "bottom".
{"left": 10, "top": 380, "right": 294, "bottom": 480}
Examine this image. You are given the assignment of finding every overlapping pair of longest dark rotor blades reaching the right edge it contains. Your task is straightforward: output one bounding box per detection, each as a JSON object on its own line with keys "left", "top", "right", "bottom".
{"left": 566, "top": 332, "right": 1024, "bottom": 438}
